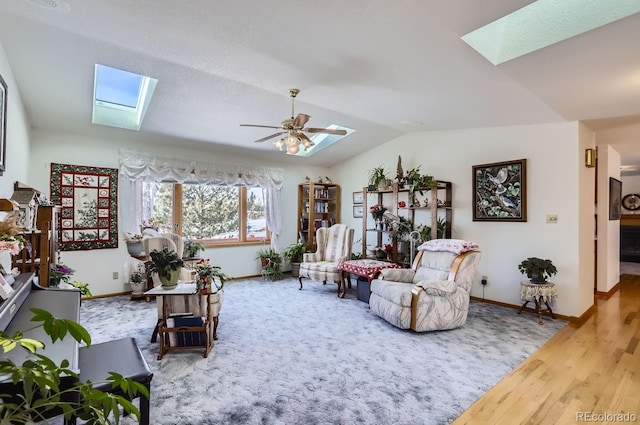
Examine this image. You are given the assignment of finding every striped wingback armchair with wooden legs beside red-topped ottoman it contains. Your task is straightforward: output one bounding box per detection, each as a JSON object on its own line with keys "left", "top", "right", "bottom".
{"left": 298, "top": 224, "right": 353, "bottom": 298}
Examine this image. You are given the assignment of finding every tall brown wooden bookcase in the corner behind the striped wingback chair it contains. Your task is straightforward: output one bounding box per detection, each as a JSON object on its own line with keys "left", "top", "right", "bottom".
{"left": 298, "top": 182, "right": 340, "bottom": 247}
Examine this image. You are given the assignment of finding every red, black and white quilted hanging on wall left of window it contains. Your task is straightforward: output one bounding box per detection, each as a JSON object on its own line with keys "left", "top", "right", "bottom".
{"left": 51, "top": 163, "right": 118, "bottom": 251}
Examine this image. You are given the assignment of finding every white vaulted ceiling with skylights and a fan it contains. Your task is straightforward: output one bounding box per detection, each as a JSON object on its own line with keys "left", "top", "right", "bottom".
{"left": 0, "top": 0, "right": 640, "bottom": 166}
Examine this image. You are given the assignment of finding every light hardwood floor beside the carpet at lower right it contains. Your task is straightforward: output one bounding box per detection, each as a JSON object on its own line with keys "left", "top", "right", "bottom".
{"left": 453, "top": 275, "right": 640, "bottom": 425}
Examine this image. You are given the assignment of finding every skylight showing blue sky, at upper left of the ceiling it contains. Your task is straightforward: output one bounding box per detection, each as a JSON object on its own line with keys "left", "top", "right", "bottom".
{"left": 92, "top": 64, "right": 158, "bottom": 130}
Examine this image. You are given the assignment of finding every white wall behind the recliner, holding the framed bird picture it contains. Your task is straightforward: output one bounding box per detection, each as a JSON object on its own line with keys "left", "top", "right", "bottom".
{"left": 332, "top": 123, "right": 593, "bottom": 316}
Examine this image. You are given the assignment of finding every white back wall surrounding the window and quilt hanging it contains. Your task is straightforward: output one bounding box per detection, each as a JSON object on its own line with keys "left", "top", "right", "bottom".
{"left": 29, "top": 130, "right": 331, "bottom": 295}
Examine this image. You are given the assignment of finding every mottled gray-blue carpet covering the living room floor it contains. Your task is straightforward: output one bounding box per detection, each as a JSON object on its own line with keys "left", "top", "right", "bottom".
{"left": 76, "top": 279, "right": 566, "bottom": 425}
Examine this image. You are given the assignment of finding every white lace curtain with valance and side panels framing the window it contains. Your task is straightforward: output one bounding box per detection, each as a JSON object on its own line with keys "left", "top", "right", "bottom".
{"left": 119, "top": 149, "right": 284, "bottom": 249}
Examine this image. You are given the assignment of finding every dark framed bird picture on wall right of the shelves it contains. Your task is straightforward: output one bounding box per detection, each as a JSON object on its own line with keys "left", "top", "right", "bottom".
{"left": 472, "top": 159, "right": 527, "bottom": 222}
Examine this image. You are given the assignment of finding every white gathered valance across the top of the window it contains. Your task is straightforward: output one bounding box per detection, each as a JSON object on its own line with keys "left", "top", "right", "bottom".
{"left": 120, "top": 149, "right": 284, "bottom": 190}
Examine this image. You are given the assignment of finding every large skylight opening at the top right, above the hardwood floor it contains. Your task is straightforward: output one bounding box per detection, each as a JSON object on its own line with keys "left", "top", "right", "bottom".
{"left": 462, "top": 0, "right": 640, "bottom": 65}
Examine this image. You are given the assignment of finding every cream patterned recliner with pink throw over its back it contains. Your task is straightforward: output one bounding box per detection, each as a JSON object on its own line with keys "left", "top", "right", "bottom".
{"left": 369, "top": 239, "right": 481, "bottom": 332}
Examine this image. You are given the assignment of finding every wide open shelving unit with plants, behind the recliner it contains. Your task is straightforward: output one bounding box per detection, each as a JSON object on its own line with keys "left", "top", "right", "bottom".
{"left": 362, "top": 181, "right": 453, "bottom": 263}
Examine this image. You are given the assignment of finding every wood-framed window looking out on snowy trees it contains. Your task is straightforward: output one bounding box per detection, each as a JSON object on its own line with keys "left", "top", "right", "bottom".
{"left": 142, "top": 183, "right": 269, "bottom": 245}
